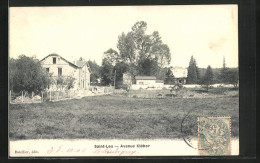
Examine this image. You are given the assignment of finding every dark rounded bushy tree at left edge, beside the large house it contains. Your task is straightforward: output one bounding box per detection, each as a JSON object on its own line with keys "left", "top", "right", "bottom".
{"left": 9, "top": 55, "right": 51, "bottom": 93}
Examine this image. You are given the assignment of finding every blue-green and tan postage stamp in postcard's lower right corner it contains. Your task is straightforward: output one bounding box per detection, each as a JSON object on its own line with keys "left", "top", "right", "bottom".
{"left": 198, "top": 117, "right": 231, "bottom": 155}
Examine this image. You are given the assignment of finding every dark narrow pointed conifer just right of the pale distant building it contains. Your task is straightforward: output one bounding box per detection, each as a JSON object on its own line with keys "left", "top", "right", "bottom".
{"left": 187, "top": 56, "right": 199, "bottom": 84}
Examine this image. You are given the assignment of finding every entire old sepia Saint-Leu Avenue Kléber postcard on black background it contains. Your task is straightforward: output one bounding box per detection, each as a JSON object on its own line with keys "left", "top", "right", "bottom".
{"left": 8, "top": 5, "right": 239, "bottom": 157}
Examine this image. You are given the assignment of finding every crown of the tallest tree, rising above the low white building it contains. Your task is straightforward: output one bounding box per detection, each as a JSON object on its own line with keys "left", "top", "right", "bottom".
{"left": 117, "top": 21, "right": 171, "bottom": 75}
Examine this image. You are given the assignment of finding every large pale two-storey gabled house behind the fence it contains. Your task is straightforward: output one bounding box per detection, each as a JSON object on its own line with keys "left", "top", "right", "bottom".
{"left": 40, "top": 54, "right": 91, "bottom": 89}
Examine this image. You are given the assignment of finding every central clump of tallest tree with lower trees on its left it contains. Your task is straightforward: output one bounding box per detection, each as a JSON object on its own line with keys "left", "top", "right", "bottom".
{"left": 101, "top": 21, "right": 171, "bottom": 85}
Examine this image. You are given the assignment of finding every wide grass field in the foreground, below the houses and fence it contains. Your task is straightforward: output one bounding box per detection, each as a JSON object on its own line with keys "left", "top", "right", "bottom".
{"left": 9, "top": 88, "right": 239, "bottom": 140}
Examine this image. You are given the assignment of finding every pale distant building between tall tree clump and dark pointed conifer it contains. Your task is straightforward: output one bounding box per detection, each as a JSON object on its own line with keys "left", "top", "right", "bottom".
{"left": 171, "top": 67, "right": 188, "bottom": 84}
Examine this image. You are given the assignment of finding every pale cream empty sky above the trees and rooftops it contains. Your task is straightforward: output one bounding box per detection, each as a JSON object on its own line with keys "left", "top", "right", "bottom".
{"left": 9, "top": 5, "right": 238, "bottom": 68}
